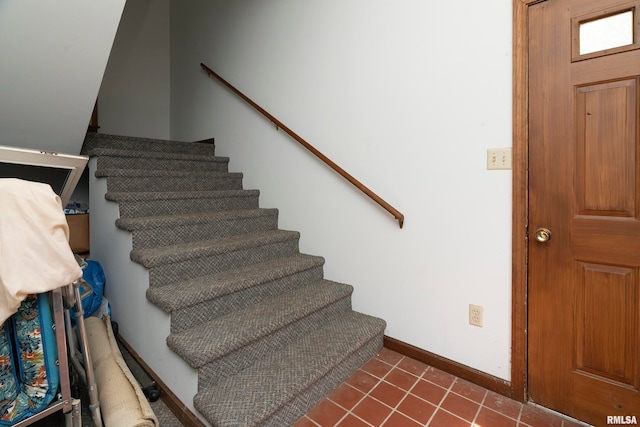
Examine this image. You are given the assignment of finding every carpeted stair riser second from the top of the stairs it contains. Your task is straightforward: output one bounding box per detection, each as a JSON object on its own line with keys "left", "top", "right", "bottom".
{"left": 97, "top": 156, "right": 228, "bottom": 172}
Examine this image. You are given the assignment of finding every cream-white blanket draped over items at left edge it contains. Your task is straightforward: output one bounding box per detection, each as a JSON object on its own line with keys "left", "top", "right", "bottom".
{"left": 0, "top": 178, "right": 82, "bottom": 324}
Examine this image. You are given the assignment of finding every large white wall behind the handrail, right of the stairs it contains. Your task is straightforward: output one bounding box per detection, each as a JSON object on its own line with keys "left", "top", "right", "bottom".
{"left": 171, "top": 0, "right": 512, "bottom": 380}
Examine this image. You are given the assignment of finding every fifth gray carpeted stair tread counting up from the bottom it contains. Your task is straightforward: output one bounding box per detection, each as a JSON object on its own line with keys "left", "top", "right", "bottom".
{"left": 116, "top": 209, "right": 278, "bottom": 231}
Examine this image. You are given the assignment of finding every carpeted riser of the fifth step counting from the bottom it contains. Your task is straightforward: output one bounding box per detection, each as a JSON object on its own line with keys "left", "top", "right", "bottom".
{"left": 133, "top": 215, "right": 278, "bottom": 250}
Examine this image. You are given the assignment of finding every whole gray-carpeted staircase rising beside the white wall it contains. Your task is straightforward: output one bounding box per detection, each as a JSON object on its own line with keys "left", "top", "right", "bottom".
{"left": 83, "top": 133, "right": 385, "bottom": 427}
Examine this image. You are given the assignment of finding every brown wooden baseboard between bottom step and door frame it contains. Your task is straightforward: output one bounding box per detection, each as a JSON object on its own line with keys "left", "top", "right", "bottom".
{"left": 384, "top": 335, "right": 521, "bottom": 400}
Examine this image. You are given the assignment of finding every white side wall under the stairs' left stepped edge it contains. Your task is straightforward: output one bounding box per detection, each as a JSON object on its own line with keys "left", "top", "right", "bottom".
{"left": 89, "top": 157, "right": 202, "bottom": 425}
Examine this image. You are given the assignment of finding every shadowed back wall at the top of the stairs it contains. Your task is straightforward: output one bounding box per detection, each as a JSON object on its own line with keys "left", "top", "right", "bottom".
{"left": 98, "top": 0, "right": 171, "bottom": 139}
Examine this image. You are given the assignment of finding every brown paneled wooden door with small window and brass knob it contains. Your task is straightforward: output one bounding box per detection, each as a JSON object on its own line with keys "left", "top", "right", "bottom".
{"left": 527, "top": 0, "right": 640, "bottom": 426}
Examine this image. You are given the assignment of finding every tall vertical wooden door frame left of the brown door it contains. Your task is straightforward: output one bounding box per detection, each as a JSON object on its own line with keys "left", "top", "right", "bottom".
{"left": 511, "top": 0, "right": 548, "bottom": 402}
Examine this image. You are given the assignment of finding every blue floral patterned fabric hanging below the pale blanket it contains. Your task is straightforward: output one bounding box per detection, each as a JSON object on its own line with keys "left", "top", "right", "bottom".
{"left": 0, "top": 294, "right": 60, "bottom": 425}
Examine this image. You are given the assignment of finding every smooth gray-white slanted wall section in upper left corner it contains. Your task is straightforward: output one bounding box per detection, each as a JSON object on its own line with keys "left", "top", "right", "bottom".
{"left": 0, "top": 0, "right": 125, "bottom": 154}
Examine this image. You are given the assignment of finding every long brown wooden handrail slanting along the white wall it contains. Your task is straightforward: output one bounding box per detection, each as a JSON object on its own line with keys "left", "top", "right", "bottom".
{"left": 200, "top": 63, "right": 404, "bottom": 228}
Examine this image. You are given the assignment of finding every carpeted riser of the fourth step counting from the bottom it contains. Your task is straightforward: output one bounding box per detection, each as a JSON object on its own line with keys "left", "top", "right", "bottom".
{"left": 149, "top": 238, "right": 298, "bottom": 286}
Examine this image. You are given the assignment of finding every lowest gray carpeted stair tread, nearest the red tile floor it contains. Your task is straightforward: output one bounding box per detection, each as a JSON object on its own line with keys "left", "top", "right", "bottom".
{"left": 194, "top": 312, "right": 386, "bottom": 427}
